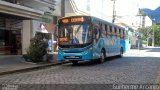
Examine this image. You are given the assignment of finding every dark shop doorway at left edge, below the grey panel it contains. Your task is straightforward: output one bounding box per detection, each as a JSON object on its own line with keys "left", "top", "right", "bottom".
{"left": 0, "top": 29, "right": 22, "bottom": 55}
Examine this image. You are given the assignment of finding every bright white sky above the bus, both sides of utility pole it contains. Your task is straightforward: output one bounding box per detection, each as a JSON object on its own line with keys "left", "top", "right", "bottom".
{"left": 74, "top": 0, "right": 160, "bottom": 26}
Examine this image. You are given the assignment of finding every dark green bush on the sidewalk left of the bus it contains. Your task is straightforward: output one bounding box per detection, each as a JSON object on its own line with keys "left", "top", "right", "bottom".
{"left": 26, "top": 35, "right": 48, "bottom": 62}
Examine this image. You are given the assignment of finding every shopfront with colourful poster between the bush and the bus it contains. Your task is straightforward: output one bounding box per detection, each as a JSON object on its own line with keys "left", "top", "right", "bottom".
{"left": 32, "top": 14, "right": 57, "bottom": 52}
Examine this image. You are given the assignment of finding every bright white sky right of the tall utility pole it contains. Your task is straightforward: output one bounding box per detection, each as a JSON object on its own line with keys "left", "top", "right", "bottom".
{"left": 116, "top": 0, "right": 160, "bottom": 26}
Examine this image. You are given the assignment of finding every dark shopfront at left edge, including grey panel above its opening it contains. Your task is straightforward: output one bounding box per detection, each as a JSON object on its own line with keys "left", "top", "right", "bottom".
{"left": 0, "top": 16, "right": 22, "bottom": 55}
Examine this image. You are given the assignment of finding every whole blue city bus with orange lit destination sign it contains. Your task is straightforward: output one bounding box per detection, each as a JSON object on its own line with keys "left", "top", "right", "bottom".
{"left": 58, "top": 16, "right": 126, "bottom": 64}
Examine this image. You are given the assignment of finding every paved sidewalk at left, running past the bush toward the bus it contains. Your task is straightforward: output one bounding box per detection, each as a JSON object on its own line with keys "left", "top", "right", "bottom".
{"left": 0, "top": 53, "right": 65, "bottom": 75}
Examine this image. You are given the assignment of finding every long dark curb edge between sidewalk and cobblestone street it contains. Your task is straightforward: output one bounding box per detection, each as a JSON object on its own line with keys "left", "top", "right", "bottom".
{"left": 0, "top": 61, "right": 69, "bottom": 76}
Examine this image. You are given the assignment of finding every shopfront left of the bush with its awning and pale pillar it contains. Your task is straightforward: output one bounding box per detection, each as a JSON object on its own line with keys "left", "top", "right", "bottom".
{"left": 0, "top": 0, "right": 44, "bottom": 55}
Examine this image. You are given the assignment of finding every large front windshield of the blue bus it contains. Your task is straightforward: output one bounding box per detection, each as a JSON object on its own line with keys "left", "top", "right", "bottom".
{"left": 59, "top": 24, "right": 92, "bottom": 45}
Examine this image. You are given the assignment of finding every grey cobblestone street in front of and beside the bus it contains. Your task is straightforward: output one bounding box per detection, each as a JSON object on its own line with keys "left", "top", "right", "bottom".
{"left": 0, "top": 47, "right": 160, "bottom": 90}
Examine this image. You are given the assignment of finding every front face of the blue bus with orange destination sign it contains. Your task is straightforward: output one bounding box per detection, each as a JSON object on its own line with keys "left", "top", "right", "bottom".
{"left": 58, "top": 16, "right": 93, "bottom": 64}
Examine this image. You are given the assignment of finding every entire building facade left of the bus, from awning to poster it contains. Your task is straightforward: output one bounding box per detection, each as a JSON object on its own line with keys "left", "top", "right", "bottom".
{"left": 0, "top": 0, "right": 60, "bottom": 55}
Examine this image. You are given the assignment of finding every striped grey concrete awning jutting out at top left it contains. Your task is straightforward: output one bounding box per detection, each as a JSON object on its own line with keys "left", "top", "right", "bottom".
{"left": 0, "top": 1, "right": 44, "bottom": 19}
